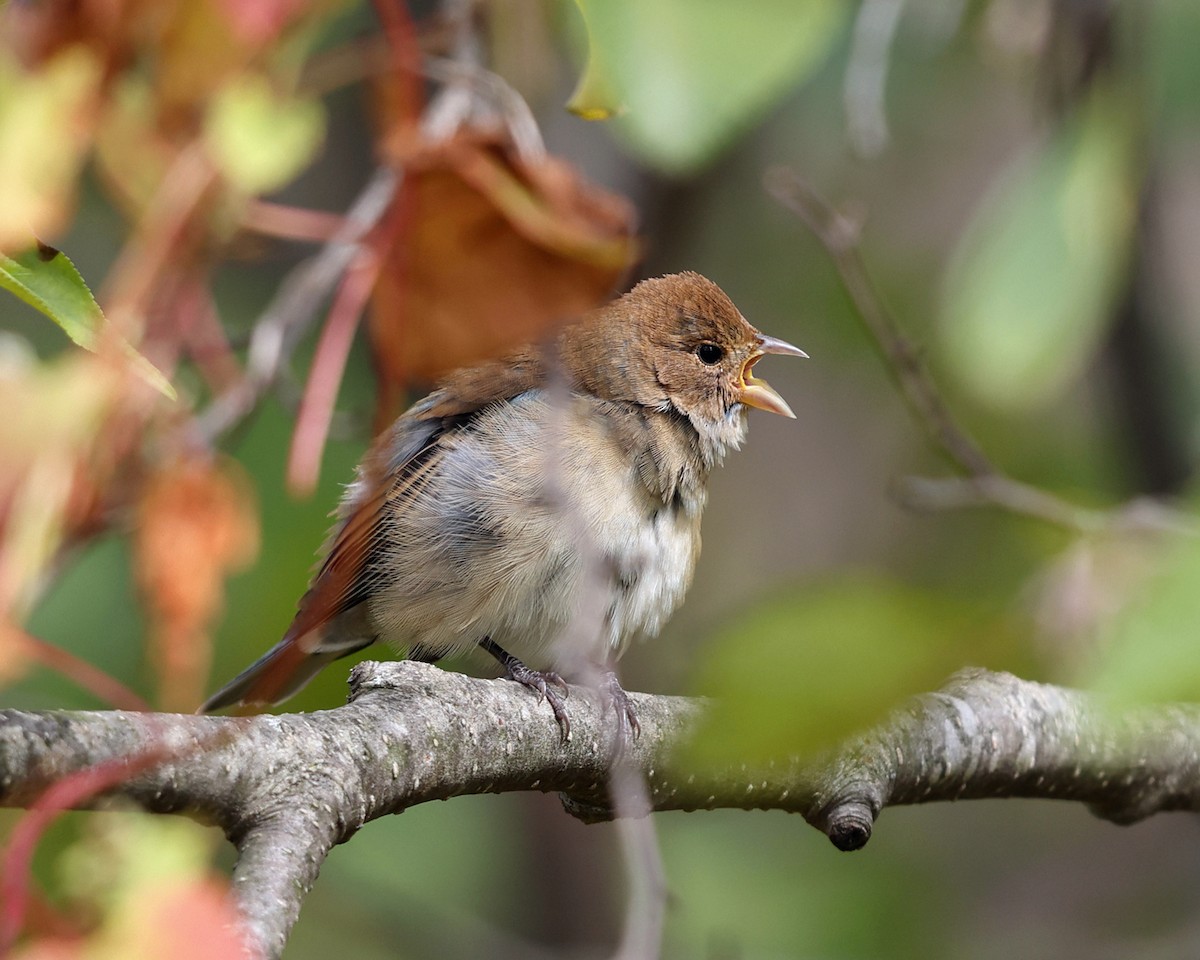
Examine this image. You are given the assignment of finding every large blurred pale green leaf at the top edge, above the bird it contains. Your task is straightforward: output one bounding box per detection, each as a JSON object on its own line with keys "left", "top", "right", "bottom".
{"left": 568, "top": 0, "right": 850, "bottom": 173}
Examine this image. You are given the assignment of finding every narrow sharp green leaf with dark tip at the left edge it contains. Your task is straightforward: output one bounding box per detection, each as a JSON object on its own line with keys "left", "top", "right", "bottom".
{"left": 0, "top": 244, "right": 175, "bottom": 400}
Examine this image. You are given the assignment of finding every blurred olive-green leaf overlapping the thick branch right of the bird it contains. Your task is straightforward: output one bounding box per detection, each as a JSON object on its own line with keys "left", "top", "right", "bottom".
{"left": 692, "top": 577, "right": 1006, "bottom": 762}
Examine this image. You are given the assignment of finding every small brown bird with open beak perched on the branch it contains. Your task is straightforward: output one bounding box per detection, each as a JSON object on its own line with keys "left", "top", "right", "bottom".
{"left": 200, "top": 272, "right": 808, "bottom": 740}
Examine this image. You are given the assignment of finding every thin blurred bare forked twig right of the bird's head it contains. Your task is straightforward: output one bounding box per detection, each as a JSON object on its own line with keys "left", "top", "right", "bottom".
{"left": 766, "top": 167, "right": 1200, "bottom": 535}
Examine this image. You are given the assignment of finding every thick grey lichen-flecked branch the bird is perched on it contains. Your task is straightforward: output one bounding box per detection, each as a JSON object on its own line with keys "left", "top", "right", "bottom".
{"left": 0, "top": 661, "right": 1200, "bottom": 958}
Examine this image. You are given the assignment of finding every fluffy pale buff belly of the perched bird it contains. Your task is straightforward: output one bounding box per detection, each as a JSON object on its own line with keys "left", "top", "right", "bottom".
{"left": 371, "top": 388, "right": 703, "bottom": 668}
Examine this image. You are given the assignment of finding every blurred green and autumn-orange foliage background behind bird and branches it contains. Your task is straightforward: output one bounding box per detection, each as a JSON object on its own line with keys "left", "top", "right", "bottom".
{"left": 0, "top": 0, "right": 1200, "bottom": 959}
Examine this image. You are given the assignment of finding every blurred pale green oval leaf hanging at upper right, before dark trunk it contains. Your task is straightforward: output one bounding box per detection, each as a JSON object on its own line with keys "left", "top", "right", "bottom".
{"left": 941, "top": 89, "right": 1136, "bottom": 409}
